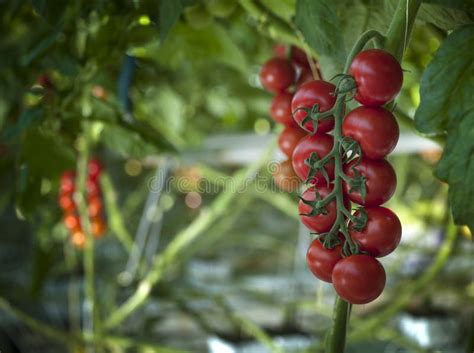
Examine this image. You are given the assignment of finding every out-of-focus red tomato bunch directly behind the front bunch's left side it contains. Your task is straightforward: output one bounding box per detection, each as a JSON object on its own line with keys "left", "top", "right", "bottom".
{"left": 260, "top": 44, "right": 317, "bottom": 192}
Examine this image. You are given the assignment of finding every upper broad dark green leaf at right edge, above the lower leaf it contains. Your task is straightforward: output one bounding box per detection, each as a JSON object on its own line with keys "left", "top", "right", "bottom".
{"left": 415, "top": 25, "right": 474, "bottom": 134}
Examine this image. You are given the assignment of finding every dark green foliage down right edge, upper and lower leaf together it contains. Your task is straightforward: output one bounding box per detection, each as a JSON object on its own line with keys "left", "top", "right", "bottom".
{"left": 415, "top": 25, "right": 474, "bottom": 230}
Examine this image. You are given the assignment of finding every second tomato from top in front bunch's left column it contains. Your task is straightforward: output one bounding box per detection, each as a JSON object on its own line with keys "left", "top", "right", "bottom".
{"left": 292, "top": 132, "right": 334, "bottom": 185}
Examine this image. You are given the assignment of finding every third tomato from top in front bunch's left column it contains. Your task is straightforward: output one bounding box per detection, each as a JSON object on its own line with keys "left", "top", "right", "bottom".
{"left": 298, "top": 185, "right": 337, "bottom": 233}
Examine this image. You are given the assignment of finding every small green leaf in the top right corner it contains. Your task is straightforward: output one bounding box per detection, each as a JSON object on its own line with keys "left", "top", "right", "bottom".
{"left": 417, "top": 4, "right": 474, "bottom": 31}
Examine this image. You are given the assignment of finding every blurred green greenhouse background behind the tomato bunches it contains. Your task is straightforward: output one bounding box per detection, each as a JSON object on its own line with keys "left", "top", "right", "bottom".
{"left": 0, "top": 0, "right": 474, "bottom": 353}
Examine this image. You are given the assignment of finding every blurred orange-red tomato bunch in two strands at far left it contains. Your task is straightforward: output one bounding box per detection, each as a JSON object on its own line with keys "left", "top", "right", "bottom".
{"left": 58, "top": 159, "right": 106, "bottom": 249}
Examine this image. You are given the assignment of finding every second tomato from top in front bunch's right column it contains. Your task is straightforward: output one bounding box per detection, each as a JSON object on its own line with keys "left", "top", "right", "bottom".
{"left": 342, "top": 106, "right": 400, "bottom": 159}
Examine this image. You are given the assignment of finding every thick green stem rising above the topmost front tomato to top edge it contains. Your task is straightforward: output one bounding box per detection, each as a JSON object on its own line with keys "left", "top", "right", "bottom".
{"left": 384, "top": 0, "right": 421, "bottom": 61}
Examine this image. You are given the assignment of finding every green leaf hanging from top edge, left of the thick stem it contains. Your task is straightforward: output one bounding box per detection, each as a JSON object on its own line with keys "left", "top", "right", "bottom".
{"left": 295, "top": 0, "right": 346, "bottom": 62}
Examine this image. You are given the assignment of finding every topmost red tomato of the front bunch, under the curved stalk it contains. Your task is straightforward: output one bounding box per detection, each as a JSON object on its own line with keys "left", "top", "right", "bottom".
{"left": 349, "top": 49, "right": 403, "bottom": 107}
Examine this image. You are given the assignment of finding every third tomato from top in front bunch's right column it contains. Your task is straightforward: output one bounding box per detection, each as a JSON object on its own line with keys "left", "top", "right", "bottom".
{"left": 344, "top": 158, "right": 397, "bottom": 206}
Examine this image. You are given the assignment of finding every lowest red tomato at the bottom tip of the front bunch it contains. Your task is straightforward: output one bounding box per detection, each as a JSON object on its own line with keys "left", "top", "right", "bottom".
{"left": 332, "top": 255, "right": 386, "bottom": 304}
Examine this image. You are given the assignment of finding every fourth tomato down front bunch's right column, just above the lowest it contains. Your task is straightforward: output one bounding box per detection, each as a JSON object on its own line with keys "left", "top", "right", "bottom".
{"left": 349, "top": 207, "right": 402, "bottom": 257}
